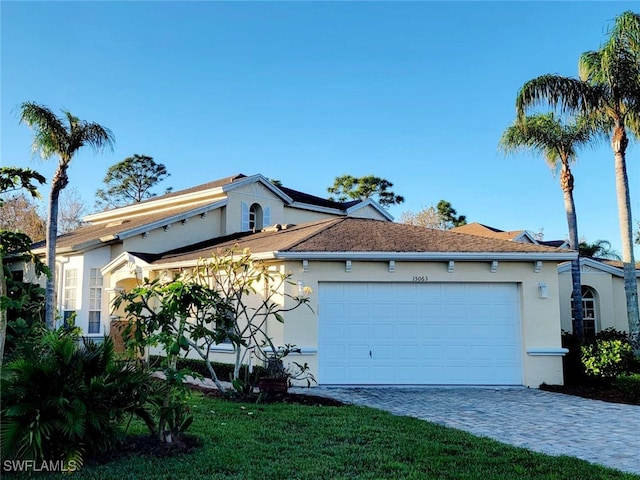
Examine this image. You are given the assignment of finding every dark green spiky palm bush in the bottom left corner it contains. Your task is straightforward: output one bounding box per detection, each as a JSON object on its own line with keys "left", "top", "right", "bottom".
{"left": 0, "top": 330, "right": 153, "bottom": 464}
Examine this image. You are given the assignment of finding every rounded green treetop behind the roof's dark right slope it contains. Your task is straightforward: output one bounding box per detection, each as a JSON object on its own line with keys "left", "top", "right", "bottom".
{"left": 327, "top": 175, "right": 404, "bottom": 207}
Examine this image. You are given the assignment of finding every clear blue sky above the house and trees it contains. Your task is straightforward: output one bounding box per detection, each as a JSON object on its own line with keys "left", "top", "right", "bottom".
{"left": 0, "top": 1, "right": 640, "bottom": 256}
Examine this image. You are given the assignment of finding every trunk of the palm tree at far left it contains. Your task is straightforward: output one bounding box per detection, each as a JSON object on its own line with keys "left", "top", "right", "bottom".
{"left": 44, "top": 160, "right": 69, "bottom": 330}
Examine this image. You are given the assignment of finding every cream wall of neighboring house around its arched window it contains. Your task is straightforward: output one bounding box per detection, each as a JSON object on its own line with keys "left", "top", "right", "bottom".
{"left": 558, "top": 266, "right": 640, "bottom": 332}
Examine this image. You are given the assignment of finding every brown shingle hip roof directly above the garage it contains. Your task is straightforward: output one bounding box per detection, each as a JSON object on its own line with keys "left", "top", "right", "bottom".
{"left": 153, "top": 217, "right": 566, "bottom": 264}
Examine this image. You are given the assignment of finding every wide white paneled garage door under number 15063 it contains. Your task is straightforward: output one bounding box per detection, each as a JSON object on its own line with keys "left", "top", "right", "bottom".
{"left": 318, "top": 282, "right": 522, "bottom": 385}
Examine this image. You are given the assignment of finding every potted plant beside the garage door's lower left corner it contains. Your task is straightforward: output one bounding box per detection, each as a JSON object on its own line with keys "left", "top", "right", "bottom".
{"left": 258, "top": 344, "right": 317, "bottom": 394}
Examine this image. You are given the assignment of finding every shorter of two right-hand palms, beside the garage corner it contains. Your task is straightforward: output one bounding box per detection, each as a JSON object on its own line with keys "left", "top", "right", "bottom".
{"left": 500, "top": 113, "right": 594, "bottom": 338}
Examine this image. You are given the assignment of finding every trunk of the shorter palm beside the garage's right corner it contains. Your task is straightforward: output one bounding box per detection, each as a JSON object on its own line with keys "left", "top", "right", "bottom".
{"left": 560, "top": 165, "right": 584, "bottom": 341}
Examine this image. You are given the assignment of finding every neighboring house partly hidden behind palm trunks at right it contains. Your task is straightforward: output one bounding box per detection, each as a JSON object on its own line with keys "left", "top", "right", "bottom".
{"left": 451, "top": 223, "right": 640, "bottom": 337}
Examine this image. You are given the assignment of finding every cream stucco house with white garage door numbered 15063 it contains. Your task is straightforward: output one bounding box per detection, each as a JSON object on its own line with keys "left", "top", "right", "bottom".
{"left": 12, "top": 175, "right": 576, "bottom": 387}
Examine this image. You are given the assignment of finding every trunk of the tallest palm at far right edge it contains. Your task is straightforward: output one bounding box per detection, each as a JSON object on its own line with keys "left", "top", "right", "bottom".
{"left": 611, "top": 124, "right": 640, "bottom": 354}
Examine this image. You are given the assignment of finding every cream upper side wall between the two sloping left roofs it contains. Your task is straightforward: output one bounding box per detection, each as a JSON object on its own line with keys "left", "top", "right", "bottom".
{"left": 121, "top": 209, "right": 224, "bottom": 258}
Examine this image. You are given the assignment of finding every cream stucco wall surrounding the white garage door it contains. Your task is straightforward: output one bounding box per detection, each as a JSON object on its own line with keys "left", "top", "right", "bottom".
{"left": 276, "top": 261, "right": 563, "bottom": 387}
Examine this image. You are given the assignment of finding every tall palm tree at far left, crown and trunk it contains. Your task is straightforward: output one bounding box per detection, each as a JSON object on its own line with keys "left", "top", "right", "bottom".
{"left": 20, "top": 102, "right": 114, "bottom": 328}
